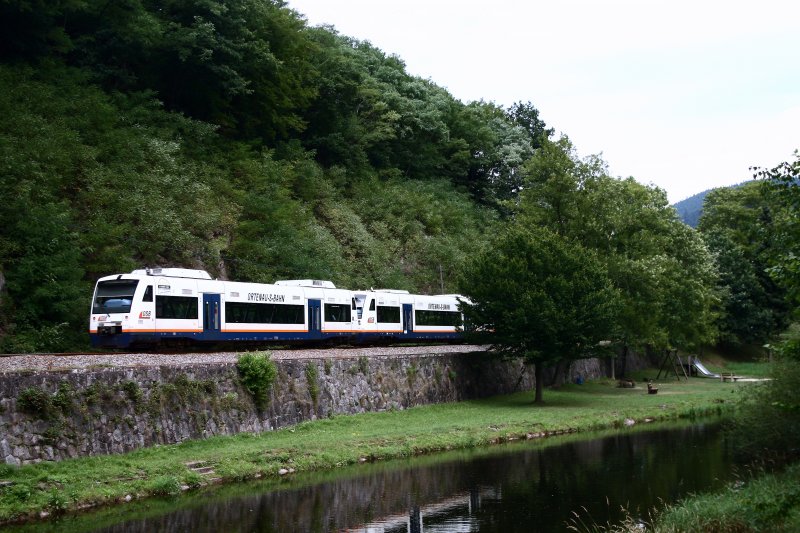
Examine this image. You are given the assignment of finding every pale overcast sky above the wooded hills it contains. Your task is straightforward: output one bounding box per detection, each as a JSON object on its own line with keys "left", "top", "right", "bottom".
{"left": 288, "top": 0, "right": 800, "bottom": 202}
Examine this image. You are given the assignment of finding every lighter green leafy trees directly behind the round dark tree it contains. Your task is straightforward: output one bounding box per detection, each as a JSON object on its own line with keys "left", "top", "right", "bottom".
{"left": 516, "top": 137, "right": 718, "bottom": 349}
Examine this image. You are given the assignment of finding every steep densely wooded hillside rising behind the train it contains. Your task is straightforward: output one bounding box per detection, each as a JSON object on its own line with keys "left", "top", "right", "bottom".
{"left": 0, "top": 0, "right": 552, "bottom": 351}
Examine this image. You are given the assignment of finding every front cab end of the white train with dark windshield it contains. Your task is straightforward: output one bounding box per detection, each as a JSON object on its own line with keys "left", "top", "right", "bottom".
{"left": 89, "top": 274, "right": 148, "bottom": 348}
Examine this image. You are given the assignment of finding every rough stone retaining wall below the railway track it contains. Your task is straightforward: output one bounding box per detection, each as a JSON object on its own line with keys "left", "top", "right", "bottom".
{"left": 0, "top": 352, "right": 603, "bottom": 465}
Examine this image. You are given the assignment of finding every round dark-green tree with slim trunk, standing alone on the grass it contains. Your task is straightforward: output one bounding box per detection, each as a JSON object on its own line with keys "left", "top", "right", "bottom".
{"left": 461, "top": 225, "right": 617, "bottom": 403}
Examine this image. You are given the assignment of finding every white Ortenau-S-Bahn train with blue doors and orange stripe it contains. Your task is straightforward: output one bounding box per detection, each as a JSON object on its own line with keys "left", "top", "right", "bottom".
{"left": 89, "top": 268, "right": 466, "bottom": 348}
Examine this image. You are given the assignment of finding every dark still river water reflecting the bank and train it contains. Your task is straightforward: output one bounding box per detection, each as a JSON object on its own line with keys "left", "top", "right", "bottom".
{"left": 18, "top": 424, "right": 732, "bottom": 533}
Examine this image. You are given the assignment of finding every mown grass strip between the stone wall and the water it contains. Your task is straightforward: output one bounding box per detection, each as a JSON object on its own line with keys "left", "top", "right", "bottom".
{"left": 0, "top": 378, "right": 746, "bottom": 522}
